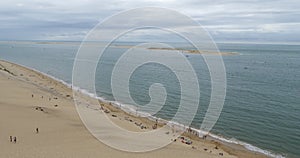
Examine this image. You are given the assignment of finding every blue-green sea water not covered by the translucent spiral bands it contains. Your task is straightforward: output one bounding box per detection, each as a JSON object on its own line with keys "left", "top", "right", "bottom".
{"left": 0, "top": 42, "right": 300, "bottom": 158}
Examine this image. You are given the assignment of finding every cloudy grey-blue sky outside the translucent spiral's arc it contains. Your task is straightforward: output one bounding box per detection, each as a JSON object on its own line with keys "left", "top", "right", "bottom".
{"left": 0, "top": 0, "right": 300, "bottom": 44}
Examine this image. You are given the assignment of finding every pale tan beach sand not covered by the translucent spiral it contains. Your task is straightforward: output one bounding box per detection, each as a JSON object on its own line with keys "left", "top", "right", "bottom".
{"left": 0, "top": 61, "right": 265, "bottom": 158}
